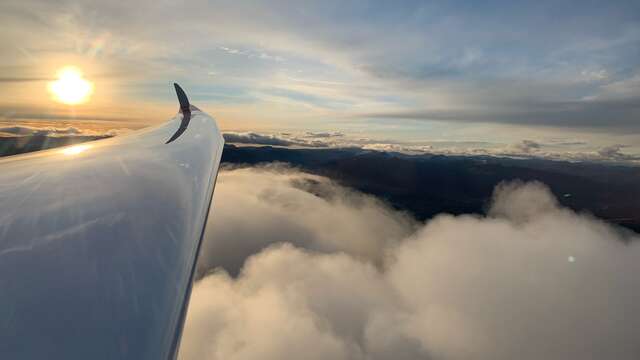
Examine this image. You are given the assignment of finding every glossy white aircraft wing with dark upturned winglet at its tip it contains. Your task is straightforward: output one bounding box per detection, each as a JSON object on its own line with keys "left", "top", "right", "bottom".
{"left": 0, "top": 85, "right": 224, "bottom": 359}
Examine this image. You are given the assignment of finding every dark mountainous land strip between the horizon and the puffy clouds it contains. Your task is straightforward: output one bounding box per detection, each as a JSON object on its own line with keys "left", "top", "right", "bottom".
{"left": 223, "top": 145, "right": 640, "bottom": 232}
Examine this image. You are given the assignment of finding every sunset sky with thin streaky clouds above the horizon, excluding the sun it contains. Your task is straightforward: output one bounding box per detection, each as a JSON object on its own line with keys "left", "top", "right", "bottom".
{"left": 0, "top": 1, "right": 640, "bottom": 160}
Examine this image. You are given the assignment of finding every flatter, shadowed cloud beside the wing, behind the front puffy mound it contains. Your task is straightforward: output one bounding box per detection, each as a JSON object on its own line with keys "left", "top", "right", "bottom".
{"left": 198, "top": 165, "right": 415, "bottom": 274}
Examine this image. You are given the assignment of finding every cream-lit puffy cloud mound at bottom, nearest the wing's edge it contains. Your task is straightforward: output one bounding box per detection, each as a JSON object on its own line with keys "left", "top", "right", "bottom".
{"left": 181, "top": 245, "right": 423, "bottom": 359}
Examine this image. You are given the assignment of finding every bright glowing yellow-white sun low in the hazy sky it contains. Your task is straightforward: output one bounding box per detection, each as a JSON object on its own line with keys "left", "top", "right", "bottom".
{"left": 49, "top": 66, "right": 93, "bottom": 105}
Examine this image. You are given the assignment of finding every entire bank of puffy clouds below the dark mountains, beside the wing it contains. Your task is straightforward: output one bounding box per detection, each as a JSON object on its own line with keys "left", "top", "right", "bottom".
{"left": 180, "top": 169, "right": 640, "bottom": 360}
